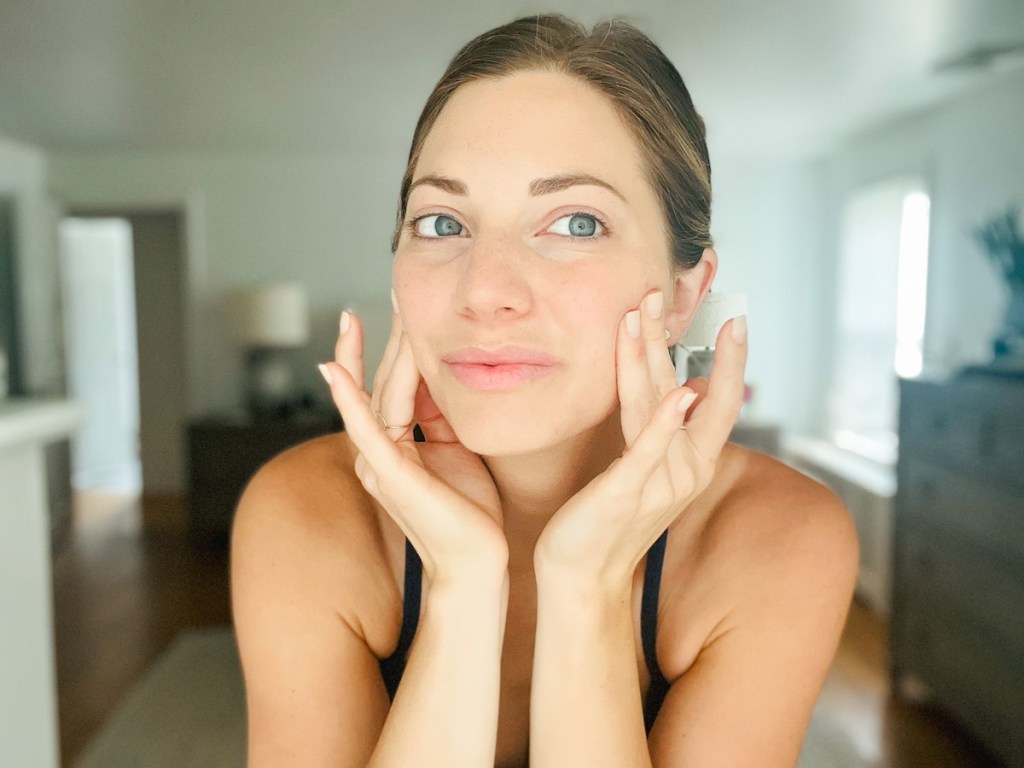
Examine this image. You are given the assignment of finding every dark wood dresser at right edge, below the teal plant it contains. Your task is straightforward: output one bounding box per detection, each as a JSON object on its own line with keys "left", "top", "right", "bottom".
{"left": 890, "top": 374, "right": 1024, "bottom": 767}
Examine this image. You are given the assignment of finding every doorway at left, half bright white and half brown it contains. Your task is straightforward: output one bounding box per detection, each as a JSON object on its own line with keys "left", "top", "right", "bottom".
{"left": 60, "top": 210, "right": 187, "bottom": 497}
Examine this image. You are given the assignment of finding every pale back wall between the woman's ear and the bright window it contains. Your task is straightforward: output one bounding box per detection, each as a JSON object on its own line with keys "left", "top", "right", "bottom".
{"left": 711, "top": 153, "right": 835, "bottom": 432}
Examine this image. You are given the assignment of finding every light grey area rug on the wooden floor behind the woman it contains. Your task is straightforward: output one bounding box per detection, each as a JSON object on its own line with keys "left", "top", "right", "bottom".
{"left": 75, "top": 629, "right": 871, "bottom": 768}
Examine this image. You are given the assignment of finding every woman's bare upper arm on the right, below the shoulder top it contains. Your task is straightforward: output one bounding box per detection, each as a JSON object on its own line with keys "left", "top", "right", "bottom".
{"left": 649, "top": 486, "right": 858, "bottom": 768}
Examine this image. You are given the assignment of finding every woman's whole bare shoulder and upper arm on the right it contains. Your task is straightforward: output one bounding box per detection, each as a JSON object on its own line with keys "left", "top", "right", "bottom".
{"left": 649, "top": 454, "right": 858, "bottom": 766}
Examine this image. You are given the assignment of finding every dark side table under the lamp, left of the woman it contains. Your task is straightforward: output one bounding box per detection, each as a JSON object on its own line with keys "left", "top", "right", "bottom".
{"left": 186, "top": 410, "right": 342, "bottom": 542}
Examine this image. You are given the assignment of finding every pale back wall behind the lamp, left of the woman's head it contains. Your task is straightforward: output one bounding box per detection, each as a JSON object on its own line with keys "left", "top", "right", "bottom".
{"left": 51, "top": 146, "right": 407, "bottom": 414}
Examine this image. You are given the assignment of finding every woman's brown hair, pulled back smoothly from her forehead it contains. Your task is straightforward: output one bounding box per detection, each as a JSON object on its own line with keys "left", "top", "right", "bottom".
{"left": 391, "top": 14, "right": 712, "bottom": 269}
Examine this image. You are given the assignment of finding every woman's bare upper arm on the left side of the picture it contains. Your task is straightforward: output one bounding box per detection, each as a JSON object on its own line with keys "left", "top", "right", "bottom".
{"left": 231, "top": 450, "right": 388, "bottom": 768}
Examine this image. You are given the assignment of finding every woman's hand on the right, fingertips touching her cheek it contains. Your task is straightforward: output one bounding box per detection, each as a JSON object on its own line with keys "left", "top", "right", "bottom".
{"left": 534, "top": 291, "right": 746, "bottom": 584}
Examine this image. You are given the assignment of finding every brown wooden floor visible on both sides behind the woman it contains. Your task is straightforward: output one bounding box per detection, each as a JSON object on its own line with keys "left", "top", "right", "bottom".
{"left": 53, "top": 495, "right": 995, "bottom": 768}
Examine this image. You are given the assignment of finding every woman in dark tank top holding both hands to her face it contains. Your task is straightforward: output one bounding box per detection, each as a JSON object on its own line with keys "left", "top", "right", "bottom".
{"left": 232, "top": 16, "right": 857, "bottom": 768}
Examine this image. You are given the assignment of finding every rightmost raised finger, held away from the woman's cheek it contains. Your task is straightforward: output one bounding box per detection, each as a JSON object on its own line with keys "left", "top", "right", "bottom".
{"left": 686, "top": 315, "right": 748, "bottom": 460}
